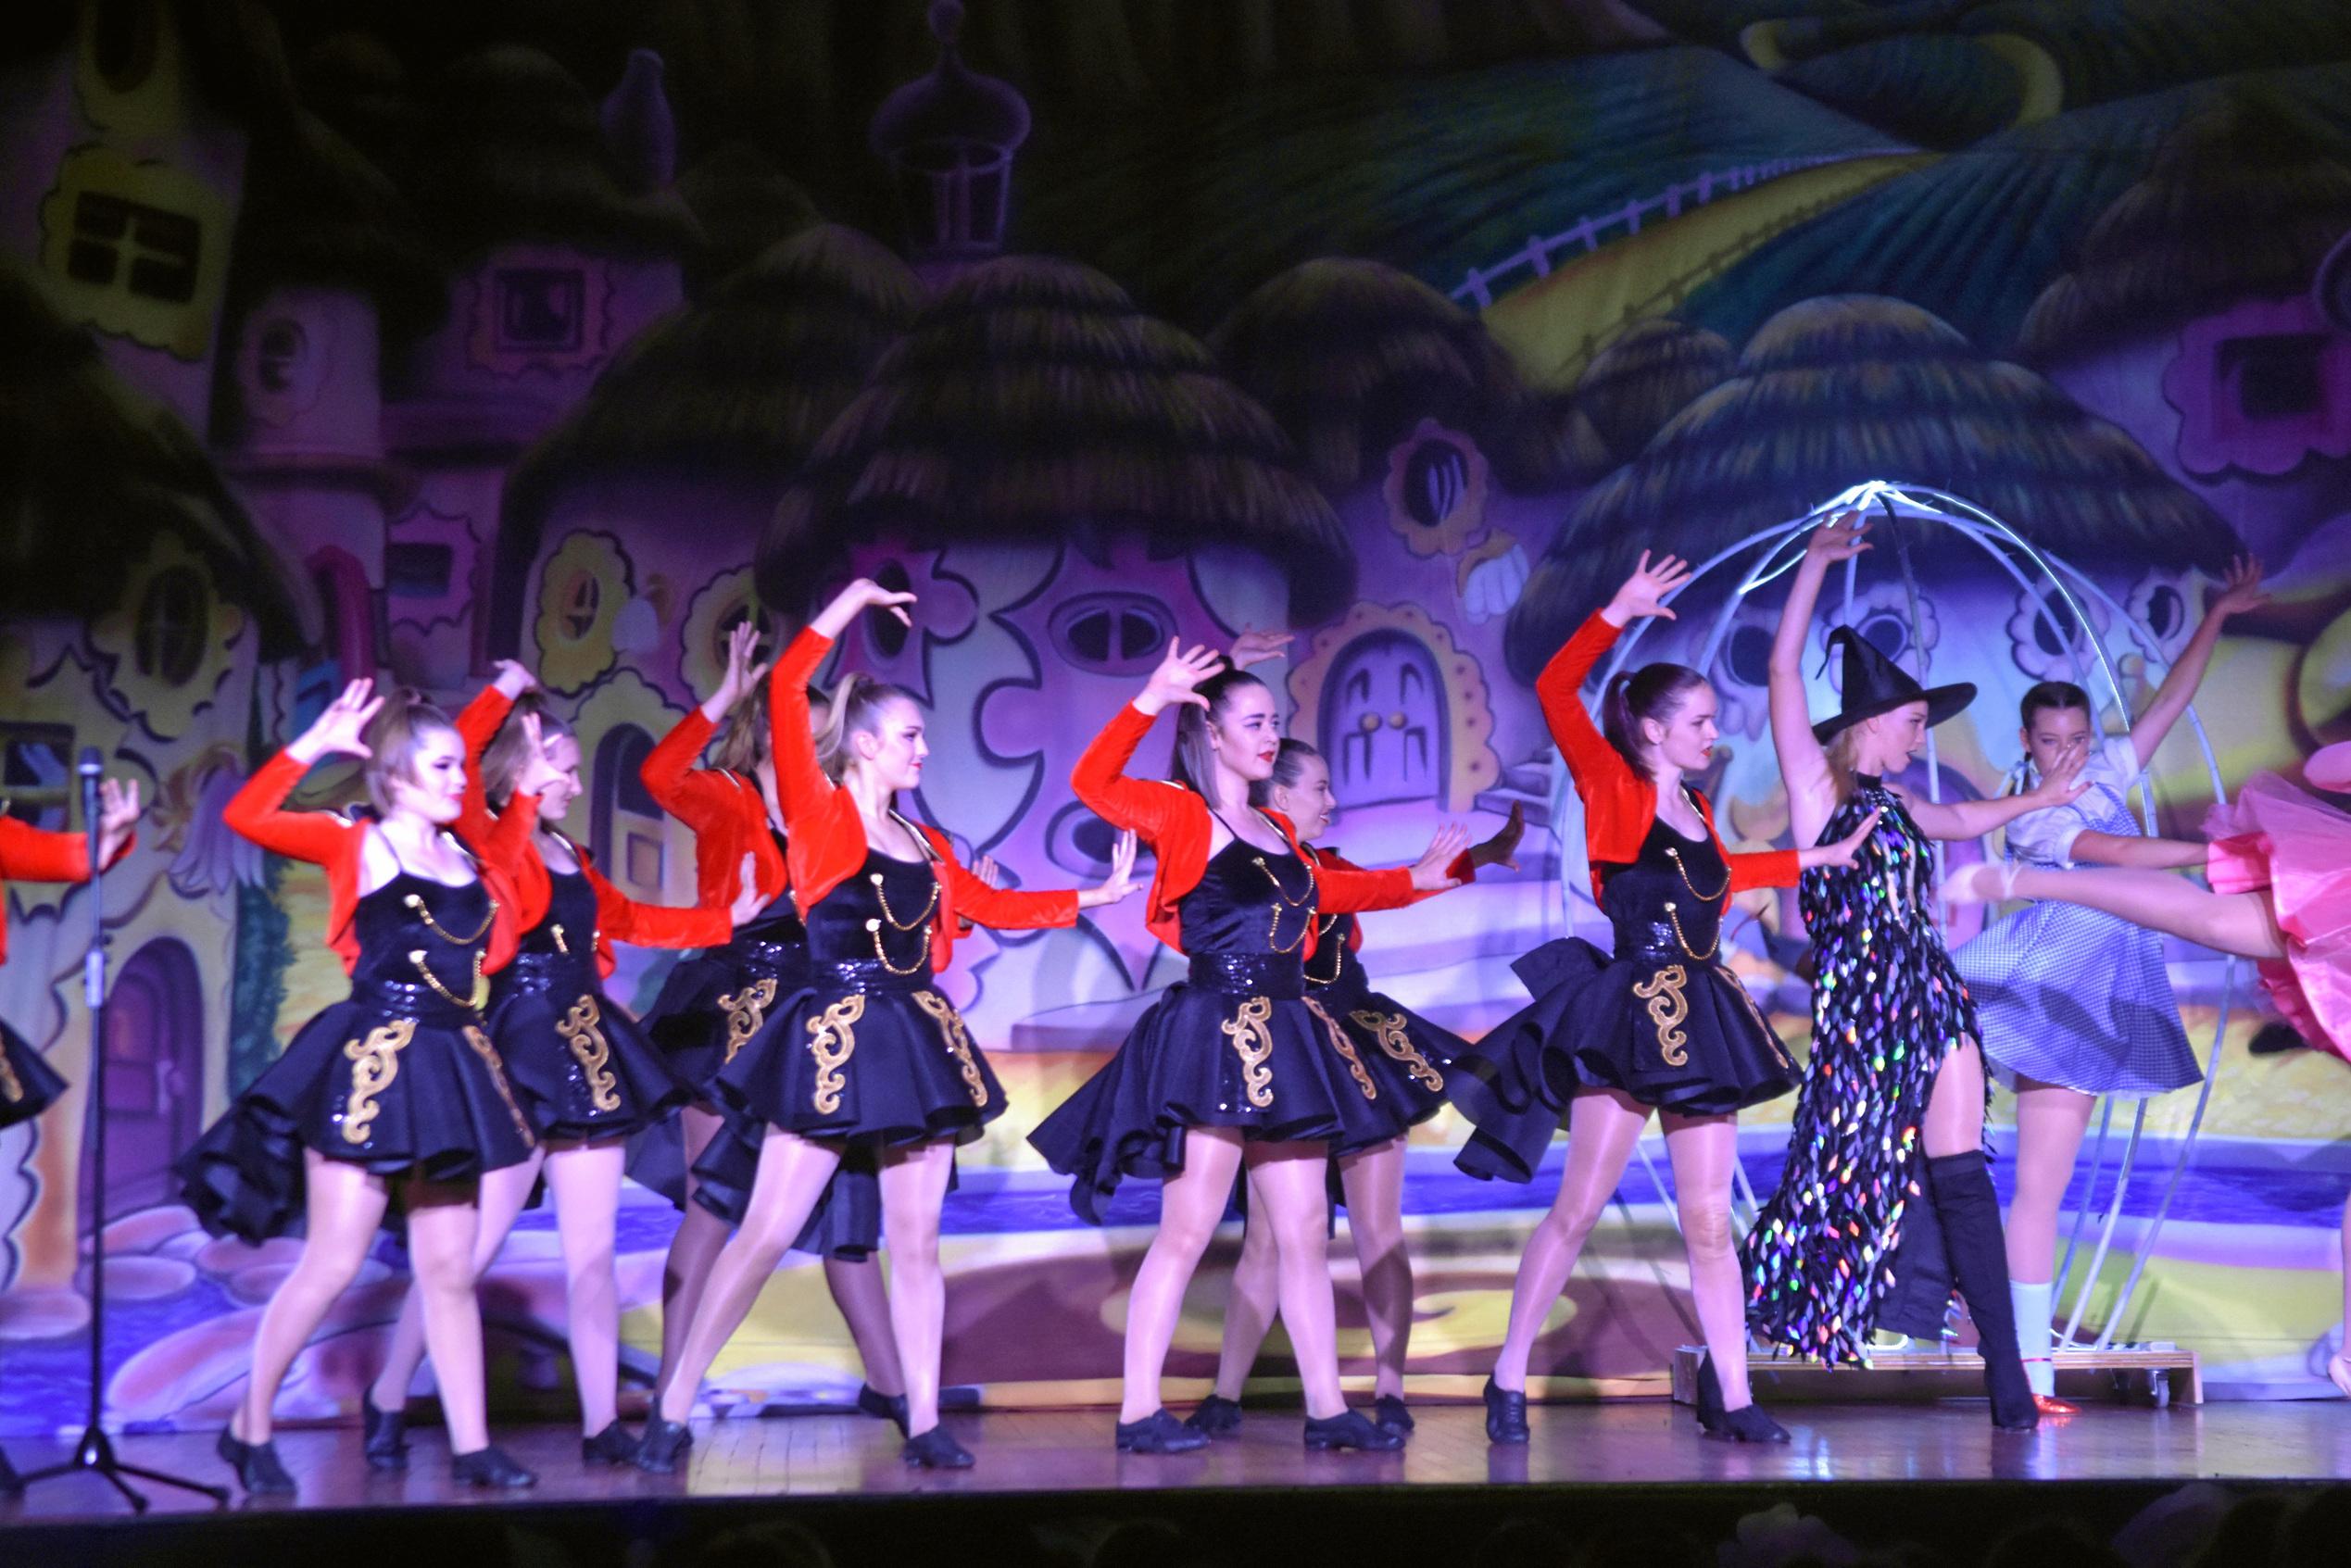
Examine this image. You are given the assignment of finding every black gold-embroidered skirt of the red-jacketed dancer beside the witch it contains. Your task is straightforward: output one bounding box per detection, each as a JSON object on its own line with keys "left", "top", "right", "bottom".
{"left": 1446, "top": 938, "right": 1801, "bottom": 1183}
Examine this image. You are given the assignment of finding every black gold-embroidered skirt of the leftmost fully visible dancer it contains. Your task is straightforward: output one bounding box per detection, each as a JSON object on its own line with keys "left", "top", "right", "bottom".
{"left": 174, "top": 980, "right": 538, "bottom": 1241}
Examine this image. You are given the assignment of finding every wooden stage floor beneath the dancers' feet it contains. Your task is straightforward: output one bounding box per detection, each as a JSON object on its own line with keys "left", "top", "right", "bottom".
{"left": 0, "top": 1401, "right": 2351, "bottom": 1568}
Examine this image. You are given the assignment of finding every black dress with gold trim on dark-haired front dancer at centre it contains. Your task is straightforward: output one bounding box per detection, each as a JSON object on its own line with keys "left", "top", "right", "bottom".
{"left": 1030, "top": 837, "right": 1406, "bottom": 1223}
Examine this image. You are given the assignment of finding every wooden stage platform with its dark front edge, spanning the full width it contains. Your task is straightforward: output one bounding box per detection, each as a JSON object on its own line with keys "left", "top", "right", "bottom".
{"left": 0, "top": 1399, "right": 2351, "bottom": 1568}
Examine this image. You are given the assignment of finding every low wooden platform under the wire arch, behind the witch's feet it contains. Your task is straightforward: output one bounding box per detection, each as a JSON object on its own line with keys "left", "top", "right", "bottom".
{"left": 1672, "top": 1345, "right": 2203, "bottom": 1411}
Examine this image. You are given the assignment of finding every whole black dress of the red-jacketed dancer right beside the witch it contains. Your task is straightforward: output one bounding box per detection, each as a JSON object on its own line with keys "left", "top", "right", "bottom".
{"left": 1448, "top": 818, "right": 1799, "bottom": 1183}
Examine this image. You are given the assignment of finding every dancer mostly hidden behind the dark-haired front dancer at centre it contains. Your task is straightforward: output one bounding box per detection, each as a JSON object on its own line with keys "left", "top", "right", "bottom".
{"left": 1185, "top": 738, "right": 1526, "bottom": 1436}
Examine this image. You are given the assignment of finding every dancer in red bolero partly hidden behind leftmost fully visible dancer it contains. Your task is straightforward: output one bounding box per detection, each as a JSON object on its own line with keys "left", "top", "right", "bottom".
{"left": 364, "top": 677, "right": 757, "bottom": 1469}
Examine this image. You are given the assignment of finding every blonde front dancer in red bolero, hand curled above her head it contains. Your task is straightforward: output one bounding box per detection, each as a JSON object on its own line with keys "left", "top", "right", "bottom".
{"left": 637, "top": 578, "right": 1133, "bottom": 1472}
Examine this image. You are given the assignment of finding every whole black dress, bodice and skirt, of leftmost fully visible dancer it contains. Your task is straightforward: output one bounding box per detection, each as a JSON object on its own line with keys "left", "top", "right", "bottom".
{"left": 176, "top": 872, "right": 536, "bottom": 1241}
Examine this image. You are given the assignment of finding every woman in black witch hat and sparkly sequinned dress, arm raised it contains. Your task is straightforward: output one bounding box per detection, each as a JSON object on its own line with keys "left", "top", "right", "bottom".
{"left": 1744, "top": 512, "right": 2083, "bottom": 1432}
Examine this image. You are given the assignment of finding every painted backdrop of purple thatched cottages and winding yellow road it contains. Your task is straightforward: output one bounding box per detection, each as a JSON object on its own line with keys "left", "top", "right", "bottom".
{"left": 0, "top": 0, "right": 2351, "bottom": 1432}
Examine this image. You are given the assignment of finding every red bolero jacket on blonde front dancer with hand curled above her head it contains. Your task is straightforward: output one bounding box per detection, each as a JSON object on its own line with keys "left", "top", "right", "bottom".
{"left": 766, "top": 630, "right": 1076, "bottom": 969}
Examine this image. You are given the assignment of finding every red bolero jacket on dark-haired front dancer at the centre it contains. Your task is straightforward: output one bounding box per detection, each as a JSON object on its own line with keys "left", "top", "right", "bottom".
{"left": 1070, "top": 703, "right": 1417, "bottom": 957}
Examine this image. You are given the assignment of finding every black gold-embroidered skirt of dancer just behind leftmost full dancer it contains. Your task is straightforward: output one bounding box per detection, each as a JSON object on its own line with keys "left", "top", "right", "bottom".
{"left": 489, "top": 952, "right": 694, "bottom": 1143}
